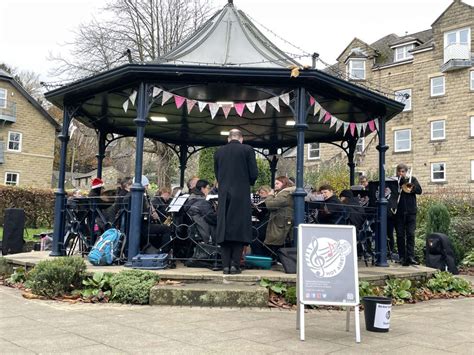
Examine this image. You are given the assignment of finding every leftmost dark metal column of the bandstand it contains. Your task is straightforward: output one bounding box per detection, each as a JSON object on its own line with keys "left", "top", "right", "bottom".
{"left": 49, "top": 106, "right": 79, "bottom": 256}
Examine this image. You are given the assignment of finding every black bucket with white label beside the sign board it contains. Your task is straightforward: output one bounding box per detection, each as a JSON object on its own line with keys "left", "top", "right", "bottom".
{"left": 362, "top": 296, "right": 392, "bottom": 333}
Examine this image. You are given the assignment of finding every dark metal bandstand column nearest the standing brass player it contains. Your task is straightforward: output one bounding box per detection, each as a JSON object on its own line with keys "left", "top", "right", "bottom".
{"left": 375, "top": 119, "right": 388, "bottom": 266}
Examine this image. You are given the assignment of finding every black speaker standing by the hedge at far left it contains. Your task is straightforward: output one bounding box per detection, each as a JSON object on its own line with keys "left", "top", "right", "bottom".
{"left": 2, "top": 208, "right": 25, "bottom": 255}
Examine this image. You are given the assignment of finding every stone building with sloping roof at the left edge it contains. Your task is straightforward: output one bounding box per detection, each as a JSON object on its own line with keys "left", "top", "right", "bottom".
{"left": 0, "top": 70, "right": 59, "bottom": 188}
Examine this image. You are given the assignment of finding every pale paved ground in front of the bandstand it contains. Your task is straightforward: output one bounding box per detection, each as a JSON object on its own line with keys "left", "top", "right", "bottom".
{"left": 0, "top": 286, "right": 474, "bottom": 355}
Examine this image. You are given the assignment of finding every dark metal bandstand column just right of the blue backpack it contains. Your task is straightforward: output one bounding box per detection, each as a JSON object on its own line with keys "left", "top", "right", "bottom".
{"left": 128, "top": 82, "right": 151, "bottom": 263}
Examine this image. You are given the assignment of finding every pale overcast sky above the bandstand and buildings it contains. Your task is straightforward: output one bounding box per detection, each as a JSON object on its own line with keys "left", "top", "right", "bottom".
{"left": 0, "top": 0, "right": 474, "bottom": 81}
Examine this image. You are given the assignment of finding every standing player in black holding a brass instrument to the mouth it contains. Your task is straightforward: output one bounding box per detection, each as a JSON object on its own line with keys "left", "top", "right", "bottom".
{"left": 395, "top": 164, "right": 422, "bottom": 266}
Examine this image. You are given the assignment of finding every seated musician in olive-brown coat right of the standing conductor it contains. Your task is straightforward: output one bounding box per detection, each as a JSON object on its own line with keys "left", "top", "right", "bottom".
{"left": 264, "top": 176, "right": 295, "bottom": 251}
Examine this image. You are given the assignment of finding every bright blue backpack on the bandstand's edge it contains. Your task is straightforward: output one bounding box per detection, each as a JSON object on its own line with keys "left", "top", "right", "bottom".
{"left": 87, "top": 228, "right": 125, "bottom": 265}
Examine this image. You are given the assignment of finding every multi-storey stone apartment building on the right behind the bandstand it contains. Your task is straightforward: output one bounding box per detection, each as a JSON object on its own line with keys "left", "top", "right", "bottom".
{"left": 306, "top": 0, "right": 474, "bottom": 192}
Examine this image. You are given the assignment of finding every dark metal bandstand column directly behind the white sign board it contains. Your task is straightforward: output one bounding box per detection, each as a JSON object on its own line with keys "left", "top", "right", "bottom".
{"left": 293, "top": 87, "right": 308, "bottom": 245}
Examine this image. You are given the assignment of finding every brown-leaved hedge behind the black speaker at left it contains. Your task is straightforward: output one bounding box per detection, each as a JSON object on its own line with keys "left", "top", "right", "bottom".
{"left": 0, "top": 185, "right": 55, "bottom": 228}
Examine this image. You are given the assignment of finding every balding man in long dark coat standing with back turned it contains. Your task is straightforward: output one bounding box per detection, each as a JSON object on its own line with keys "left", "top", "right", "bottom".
{"left": 214, "top": 129, "right": 258, "bottom": 274}
